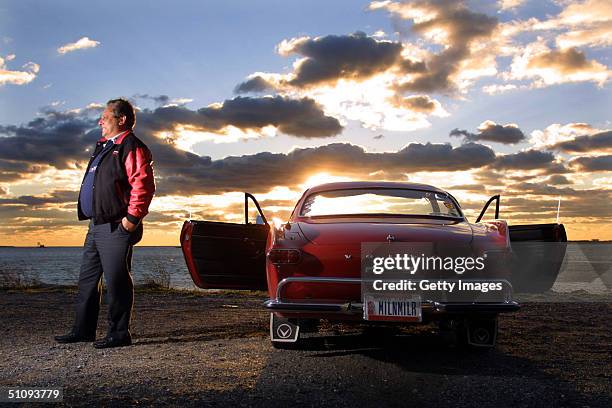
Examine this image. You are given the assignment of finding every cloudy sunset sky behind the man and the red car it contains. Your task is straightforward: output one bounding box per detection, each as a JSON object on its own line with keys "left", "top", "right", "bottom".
{"left": 0, "top": 0, "right": 612, "bottom": 246}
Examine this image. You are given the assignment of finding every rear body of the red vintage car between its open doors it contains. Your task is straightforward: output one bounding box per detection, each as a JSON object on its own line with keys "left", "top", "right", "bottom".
{"left": 266, "top": 182, "right": 518, "bottom": 346}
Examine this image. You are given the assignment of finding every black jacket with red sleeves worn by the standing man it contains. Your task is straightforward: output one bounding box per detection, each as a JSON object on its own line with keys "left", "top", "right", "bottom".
{"left": 78, "top": 131, "right": 155, "bottom": 224}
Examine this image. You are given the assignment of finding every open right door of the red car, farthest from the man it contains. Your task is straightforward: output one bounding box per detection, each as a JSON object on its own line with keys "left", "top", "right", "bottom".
{"left": 476, "top": 195, "right": 567, "bottom": 293}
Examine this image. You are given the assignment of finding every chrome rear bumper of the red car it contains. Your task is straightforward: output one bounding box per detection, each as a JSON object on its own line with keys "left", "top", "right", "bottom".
{"left": 264, "top": 277, "right": 521, "bottom": 315}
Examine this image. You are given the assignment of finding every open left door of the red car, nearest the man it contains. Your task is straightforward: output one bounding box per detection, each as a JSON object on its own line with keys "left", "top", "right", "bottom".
{"left": 181, "top": 193, "right": 270, "bottom": 290}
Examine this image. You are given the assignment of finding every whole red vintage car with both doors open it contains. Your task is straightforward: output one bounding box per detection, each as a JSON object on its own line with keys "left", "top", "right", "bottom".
{"left": 181, "top": 182, "right": 567, "bottom": 348}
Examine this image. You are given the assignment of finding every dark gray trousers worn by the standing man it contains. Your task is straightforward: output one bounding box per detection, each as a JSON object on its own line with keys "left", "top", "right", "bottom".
{"left": 73, "top": 222, "right": 142, "bottom": 339}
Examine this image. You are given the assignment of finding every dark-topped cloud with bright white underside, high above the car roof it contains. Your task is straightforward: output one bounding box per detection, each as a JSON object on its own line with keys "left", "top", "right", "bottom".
{"left": 235, "top": 37, "right": 448, "bottom": 131}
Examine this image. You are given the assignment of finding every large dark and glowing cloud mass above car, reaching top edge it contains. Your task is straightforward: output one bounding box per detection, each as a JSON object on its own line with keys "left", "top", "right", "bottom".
{"left": 234, "top": 0, "right": 498, "bottom": 131}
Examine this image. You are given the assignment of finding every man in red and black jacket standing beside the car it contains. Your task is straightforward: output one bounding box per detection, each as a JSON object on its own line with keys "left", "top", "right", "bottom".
{"left": 55, "top": 99, "right": 155, "bottom": 348}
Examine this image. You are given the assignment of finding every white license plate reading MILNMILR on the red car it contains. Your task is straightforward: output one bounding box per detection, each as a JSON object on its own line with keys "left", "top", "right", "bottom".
{"left": 363, "top": 296, "right": 423, "bottom": 322}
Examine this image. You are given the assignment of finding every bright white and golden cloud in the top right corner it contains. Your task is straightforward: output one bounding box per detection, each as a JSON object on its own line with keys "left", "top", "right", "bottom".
{"left": 485, "top": 0, "right": 612, "bottom": 92}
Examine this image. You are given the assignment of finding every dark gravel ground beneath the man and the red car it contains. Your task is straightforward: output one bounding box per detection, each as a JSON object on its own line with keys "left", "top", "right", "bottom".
{"left": 0, "top": 289, "right": 612, "bottom": 407}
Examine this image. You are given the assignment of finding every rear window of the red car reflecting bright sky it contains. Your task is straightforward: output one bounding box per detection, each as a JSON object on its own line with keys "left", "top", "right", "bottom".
{"left": 300, "top": 188, "right": 461, "bottom": 218}
